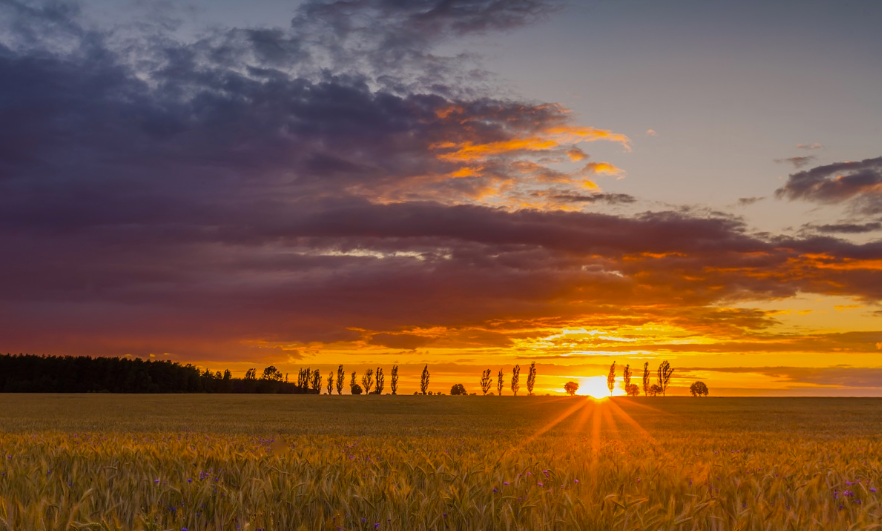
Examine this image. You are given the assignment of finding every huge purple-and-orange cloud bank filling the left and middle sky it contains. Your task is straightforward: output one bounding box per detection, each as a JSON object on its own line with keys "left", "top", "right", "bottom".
{"left": 0, "top": 0, "right": 882, "bottom": 359}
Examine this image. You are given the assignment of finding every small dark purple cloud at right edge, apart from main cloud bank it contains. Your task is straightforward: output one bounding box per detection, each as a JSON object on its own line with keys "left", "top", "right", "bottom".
{"left": 775, "top": 157, "right": 882, "bottom": 211}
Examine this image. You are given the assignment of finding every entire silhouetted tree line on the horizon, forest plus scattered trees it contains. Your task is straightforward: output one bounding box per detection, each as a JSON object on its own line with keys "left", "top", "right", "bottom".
{"left": 0, "top": 354, "right": 708, "bottom": 396}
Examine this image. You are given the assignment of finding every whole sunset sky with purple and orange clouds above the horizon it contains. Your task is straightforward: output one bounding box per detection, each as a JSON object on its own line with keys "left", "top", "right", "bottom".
{"left": 0, "top": 0, "right": 882, "bottom": 396}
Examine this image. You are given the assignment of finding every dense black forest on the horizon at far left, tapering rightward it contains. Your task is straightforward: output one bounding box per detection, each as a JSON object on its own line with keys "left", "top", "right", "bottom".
{"left": 0, "top": 354, "right": 319, "bottom": 394}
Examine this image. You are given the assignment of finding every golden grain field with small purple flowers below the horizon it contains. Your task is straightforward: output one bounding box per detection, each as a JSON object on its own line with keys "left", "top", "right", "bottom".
{"left": 0, "top": 395, "right": 882, "bottom": 531}
